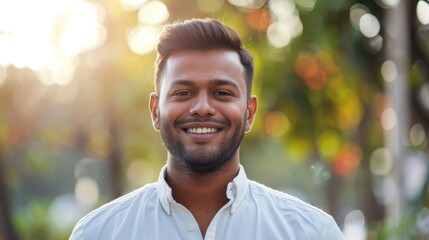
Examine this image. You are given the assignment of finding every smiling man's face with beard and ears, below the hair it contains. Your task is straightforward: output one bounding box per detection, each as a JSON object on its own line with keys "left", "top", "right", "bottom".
{"left": 150, "top": 49, "right": 257, "bottom": 174}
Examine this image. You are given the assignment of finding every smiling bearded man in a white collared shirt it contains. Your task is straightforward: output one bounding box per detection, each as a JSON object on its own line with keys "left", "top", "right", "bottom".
{"left": 70, "top": 19, "right": 343, "bottom": 240}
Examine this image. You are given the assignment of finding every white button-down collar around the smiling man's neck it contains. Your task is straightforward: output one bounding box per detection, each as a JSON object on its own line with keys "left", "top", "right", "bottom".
{"left": 157, "top": 165, "right": 249, "bottom": 215}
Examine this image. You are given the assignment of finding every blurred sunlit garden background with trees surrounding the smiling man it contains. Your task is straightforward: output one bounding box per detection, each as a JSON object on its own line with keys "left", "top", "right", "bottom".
{"left": 0, "top": 0, "right": 429, "bottom": 240}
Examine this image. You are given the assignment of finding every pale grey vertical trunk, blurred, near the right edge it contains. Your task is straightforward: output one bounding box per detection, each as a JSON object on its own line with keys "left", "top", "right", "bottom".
{"left": 385, "top": 1, "right": 410, "bottom": 225}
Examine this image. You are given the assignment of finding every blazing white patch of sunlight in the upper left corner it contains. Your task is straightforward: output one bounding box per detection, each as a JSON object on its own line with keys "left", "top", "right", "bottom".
{"left": 0, "top": 0, "right": 106, "bottom": 85}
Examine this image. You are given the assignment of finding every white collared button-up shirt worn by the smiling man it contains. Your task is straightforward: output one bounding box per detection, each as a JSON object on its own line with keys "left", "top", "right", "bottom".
{"left": 70, "top": 166, "right": 343, "bottom": 240}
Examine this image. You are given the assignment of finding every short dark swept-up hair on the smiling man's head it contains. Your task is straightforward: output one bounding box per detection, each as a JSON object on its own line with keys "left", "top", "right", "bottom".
{"left": 155, "top": 18, "right": 253, "bottom": 97}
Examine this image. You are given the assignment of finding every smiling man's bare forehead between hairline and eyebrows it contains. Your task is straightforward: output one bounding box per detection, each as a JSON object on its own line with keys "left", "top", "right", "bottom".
{"left": 161, "top": 49, "right": 246, "bottom": 88}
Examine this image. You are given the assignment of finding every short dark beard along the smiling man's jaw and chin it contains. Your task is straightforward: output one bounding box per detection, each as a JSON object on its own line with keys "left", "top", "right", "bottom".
{"left": 160, "top": 115, "right": 246, "bottom": 176}
